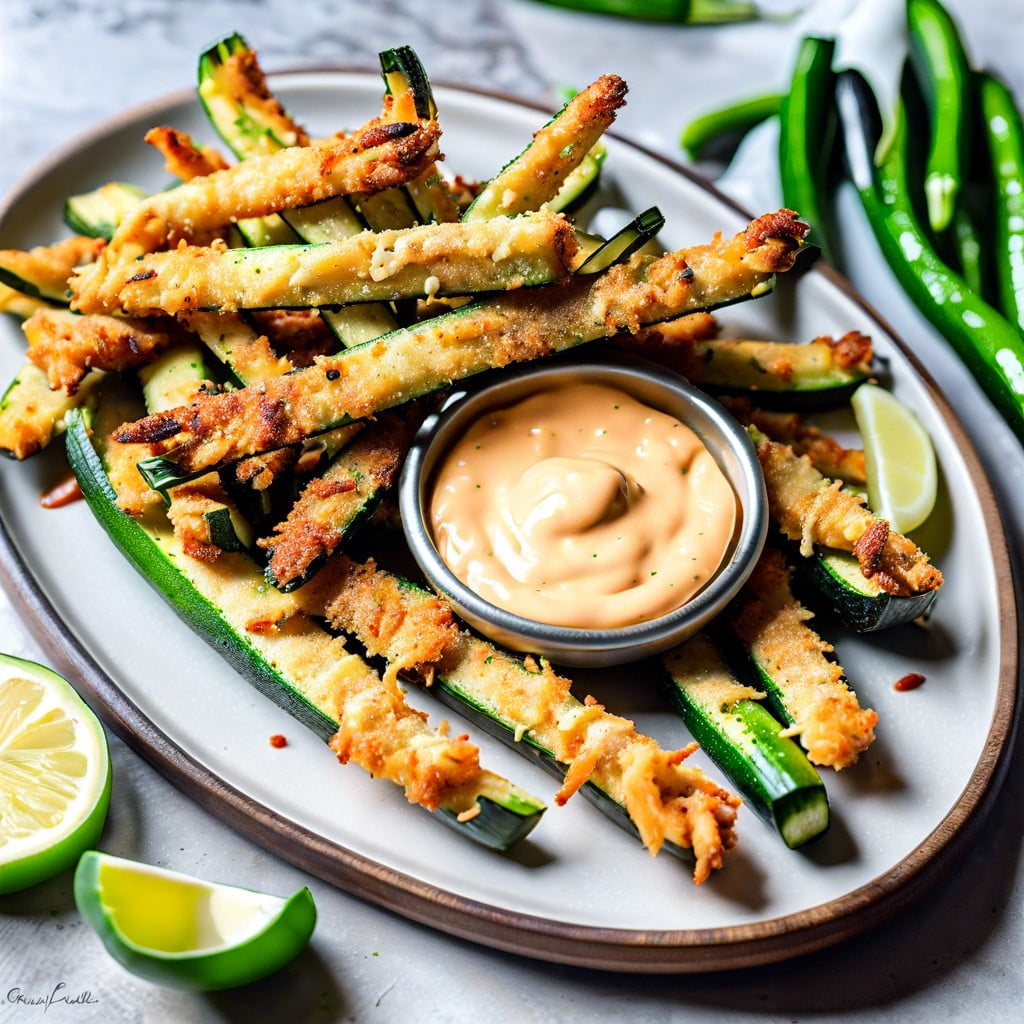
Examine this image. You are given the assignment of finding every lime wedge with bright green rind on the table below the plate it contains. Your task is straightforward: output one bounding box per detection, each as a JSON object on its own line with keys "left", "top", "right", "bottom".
{"left": 75, "top": 850, "right": 316, "bottom": 990}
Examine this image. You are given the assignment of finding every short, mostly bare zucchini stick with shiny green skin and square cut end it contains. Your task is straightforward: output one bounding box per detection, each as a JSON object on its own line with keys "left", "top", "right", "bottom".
{"left": 662, "top": 633, "right": 829, "bottom": 849}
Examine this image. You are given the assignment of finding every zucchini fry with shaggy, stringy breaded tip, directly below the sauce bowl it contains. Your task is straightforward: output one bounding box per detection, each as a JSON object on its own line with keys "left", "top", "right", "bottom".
{"left": 296, "top": 556, "right": 739, "bottom": 883}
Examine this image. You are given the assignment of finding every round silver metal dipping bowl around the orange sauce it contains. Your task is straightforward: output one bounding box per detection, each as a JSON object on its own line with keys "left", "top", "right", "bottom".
{"left": 399, "top": 355, "right": 768, "bottom": 667}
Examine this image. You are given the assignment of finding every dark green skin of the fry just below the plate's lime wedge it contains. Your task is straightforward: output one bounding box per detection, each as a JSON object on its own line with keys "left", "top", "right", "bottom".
{"left": 793, "top": 551, "right": 939, "bottom": 633}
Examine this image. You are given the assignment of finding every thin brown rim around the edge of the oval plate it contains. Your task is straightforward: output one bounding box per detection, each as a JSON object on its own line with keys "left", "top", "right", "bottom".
{"left": 0, "top": 67, "right": 1018, "bottom": 973}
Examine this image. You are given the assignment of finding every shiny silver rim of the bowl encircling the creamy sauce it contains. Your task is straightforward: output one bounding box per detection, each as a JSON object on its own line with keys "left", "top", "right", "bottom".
{"left": 398, "top": 353, "right": 768, "bottom": 657}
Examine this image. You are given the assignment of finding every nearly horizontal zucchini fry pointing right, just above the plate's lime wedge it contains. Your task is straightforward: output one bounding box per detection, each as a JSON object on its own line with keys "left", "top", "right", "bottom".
{"left": 625, "top": 324, "right": 872, "bottom": 409}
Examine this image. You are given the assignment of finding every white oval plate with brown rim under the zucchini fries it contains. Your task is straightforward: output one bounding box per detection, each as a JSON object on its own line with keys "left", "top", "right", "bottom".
{"left": 0, "top": 72, "right": 1016, "bottom": 971}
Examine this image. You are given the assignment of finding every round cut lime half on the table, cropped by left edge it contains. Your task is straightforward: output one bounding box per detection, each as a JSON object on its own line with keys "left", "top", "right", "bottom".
{"left": 0, "top": 654, "right": 111, "bottom": 893}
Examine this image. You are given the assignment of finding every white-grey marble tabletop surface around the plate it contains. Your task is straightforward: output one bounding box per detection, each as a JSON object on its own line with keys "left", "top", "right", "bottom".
{"left": 0, "top": 0, "right": 1024, "bottom": 1024}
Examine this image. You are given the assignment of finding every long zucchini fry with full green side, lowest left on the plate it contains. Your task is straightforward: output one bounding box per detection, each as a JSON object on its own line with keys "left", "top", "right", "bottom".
{"left": 68, "top": 399, "right": 544, "bottom": 849}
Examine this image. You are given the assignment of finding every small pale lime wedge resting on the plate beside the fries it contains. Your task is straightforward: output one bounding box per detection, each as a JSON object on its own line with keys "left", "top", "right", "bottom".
{"left": 852, "top": 384, "right": 939, "bottom": 534}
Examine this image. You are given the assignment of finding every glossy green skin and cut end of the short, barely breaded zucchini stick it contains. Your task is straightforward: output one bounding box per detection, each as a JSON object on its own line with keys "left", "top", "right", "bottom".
{"left": 662, "top": 637, "right": 829, "bottom": 849}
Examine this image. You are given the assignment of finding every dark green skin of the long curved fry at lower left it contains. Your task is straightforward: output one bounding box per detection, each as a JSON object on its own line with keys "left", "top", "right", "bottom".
{"left": 67, "top": 410, "right": 544, "bottom": 850}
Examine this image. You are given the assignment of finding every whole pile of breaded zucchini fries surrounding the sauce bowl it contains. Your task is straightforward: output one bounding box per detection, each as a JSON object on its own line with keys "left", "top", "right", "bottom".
{"left": 0, "top": 35, "right": 941, "bottom": 881}
